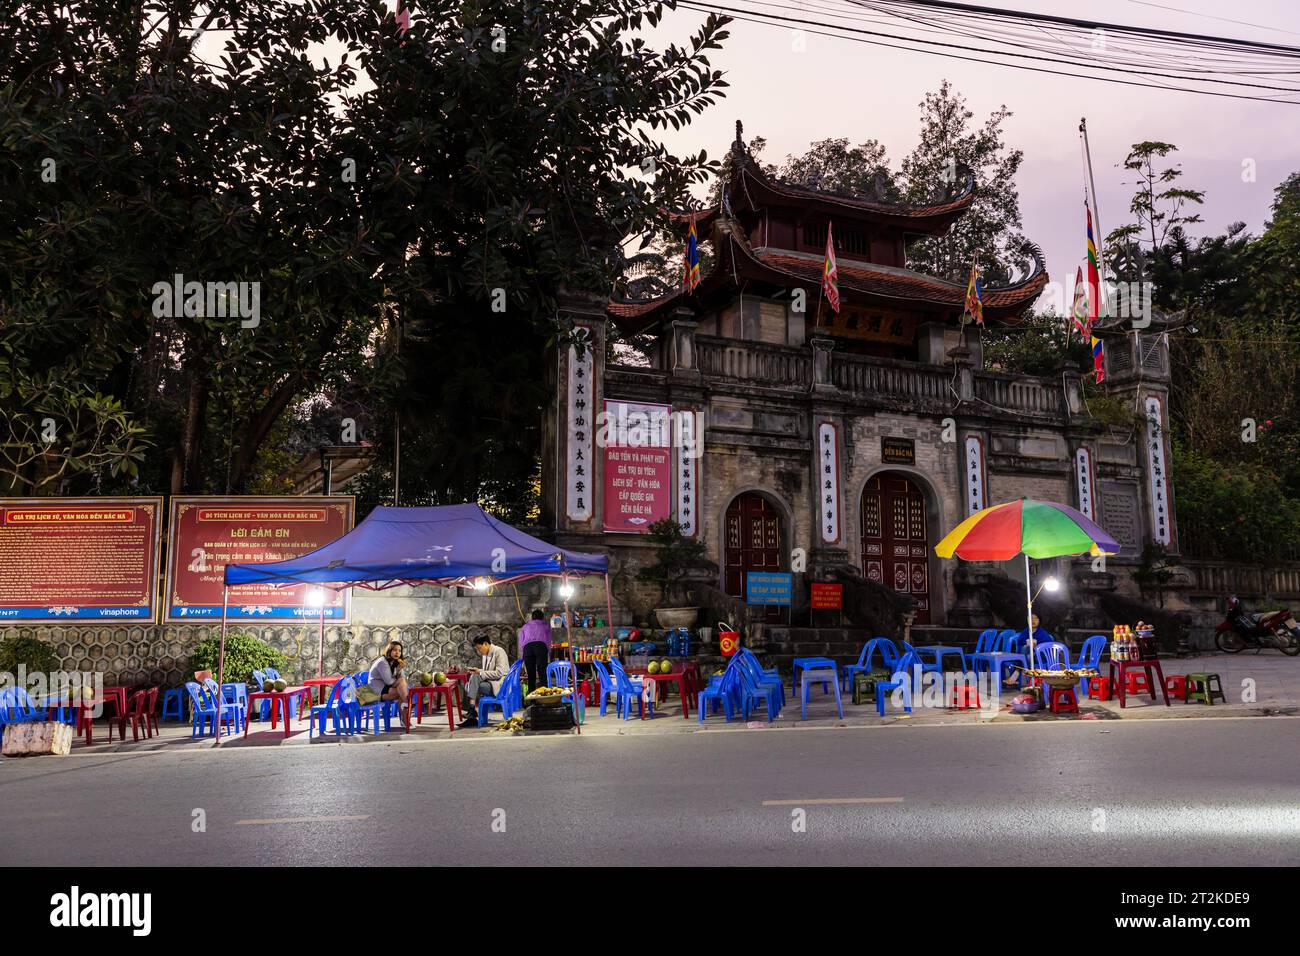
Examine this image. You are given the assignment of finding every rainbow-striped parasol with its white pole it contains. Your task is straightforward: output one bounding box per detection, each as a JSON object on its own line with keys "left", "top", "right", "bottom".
{"left": 935, "top": 498, "right": 1119, "bottom": 667}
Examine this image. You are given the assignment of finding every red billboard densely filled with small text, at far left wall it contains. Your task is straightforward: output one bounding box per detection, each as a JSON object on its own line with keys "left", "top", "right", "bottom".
{"left": 0, "top": 498, "right": 163, "bottom": 624}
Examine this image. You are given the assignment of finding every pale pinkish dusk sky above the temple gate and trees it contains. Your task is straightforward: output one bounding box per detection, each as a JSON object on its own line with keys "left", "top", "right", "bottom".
{"left": 642, "top": 0, "right": 1300, "bottom": 304}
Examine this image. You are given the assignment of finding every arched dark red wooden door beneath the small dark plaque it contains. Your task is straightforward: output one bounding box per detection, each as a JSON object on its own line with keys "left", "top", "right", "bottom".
{"left": 862, "top": 471, "right": 930, "bottom": 624}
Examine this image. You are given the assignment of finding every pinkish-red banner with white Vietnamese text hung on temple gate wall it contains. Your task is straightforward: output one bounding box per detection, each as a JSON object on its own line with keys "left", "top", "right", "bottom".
{"left": 597, "top": 399, "right": 672, "bottom": 535}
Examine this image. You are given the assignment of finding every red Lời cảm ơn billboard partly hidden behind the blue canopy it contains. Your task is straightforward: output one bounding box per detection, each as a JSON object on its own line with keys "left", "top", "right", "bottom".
{"left": 164, "top": 496, "right": 356, "bottom": 623}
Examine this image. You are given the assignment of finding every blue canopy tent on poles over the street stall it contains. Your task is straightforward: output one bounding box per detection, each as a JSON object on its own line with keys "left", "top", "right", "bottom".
{"left": 217, "top": 505, "right": 614, "bottom": 712}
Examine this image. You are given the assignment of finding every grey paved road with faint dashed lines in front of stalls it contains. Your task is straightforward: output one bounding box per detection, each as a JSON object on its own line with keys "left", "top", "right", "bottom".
{"left": 0, "top": 718, "right": 1300, "bottom": 865}
